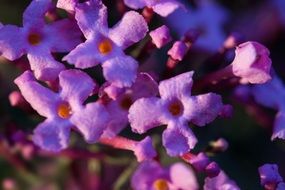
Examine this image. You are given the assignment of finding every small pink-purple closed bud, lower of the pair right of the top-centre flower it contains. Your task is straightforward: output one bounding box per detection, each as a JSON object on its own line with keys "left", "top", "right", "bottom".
{"left": 167, "top": 41, "right": 188, "bottom": 61}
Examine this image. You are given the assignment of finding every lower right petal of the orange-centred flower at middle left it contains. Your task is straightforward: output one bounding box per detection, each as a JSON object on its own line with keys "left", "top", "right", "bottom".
{"left": 70, "top": 103, "right": 110, "bottom": 143}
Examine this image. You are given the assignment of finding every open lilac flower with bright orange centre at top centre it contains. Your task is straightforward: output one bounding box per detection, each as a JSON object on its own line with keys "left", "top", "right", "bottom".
{"left": 63, "top": 0, "right": 148, "bottom": 87}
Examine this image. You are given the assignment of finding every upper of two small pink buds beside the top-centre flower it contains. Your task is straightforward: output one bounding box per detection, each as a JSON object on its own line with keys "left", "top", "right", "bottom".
{"left": 149, "top": 25, "right": 171, "bottom": 48}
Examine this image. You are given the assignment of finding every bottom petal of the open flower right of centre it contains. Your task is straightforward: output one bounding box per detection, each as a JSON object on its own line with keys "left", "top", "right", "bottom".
{"left": 162, "top": 123, "right": 197, "bottom": 156}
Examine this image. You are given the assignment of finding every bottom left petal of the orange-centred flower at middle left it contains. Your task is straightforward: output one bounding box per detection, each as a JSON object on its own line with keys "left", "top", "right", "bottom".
{"left": 33, "top": 120, "right": 70, "bottom": 152}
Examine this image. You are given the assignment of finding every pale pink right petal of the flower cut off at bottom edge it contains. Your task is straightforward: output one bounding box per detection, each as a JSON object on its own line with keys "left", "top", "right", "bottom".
{"left": 169, "top": 163, "right": 199, "bottom": 190}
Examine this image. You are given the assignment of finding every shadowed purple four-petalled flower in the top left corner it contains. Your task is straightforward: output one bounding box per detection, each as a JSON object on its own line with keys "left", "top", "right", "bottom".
{"left": 0, "top": 0, "right": 80, "bottom": 80}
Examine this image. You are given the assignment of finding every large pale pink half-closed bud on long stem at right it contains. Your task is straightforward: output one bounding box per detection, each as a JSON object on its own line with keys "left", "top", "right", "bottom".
{"left": 232, "top": 41, "right": 271, "bottom": 84}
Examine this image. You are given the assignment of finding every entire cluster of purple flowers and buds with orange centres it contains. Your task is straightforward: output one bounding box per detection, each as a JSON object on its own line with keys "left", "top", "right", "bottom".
{"left": 0, "top": 0, "right": 280, "bottom": 190}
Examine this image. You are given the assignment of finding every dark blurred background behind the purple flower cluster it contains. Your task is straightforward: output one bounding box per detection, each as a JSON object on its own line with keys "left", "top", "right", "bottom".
{"left": 0, "top": 0, "right": 285, "bottom": 190}
